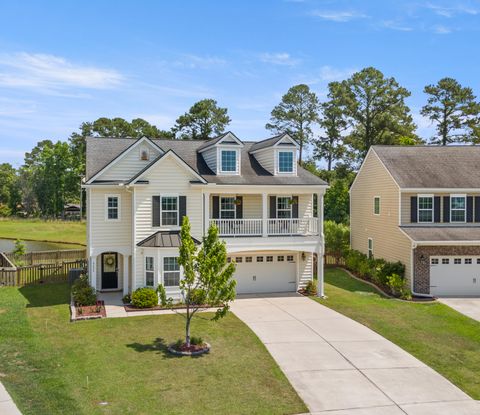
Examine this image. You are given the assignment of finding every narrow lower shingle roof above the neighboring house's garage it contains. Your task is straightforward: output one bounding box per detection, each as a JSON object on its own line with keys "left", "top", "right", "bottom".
{"left": 400, "top": 225, "right": 480, "bottom": 242}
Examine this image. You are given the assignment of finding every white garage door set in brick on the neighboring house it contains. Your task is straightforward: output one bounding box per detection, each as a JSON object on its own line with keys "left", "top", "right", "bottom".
{"left": 430, "top": 256, "right": 480, "bottom": 296}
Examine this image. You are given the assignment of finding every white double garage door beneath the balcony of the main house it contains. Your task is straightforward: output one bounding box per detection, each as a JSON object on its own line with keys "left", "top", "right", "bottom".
{"left": 231, "top": 254, "right": 297, "bottom": 294}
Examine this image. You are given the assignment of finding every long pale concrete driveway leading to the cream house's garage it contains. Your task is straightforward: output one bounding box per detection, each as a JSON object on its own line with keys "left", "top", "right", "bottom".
{"left": 232, "top": 294, "right": 480, "bottom": 415}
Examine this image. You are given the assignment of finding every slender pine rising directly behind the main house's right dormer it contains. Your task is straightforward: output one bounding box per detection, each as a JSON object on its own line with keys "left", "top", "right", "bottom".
{"left": 265, "top": 84, "right": 319, "bottom": 163}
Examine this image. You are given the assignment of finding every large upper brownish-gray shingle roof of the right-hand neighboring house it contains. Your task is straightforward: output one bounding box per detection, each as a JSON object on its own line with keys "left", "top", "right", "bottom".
{"left": 372, "top": 145, "right": 480, "bottom": 189}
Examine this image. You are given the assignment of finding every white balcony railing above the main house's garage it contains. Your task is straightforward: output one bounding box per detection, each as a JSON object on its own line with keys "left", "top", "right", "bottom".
{"left": 210, "top": 218, "right": 318, "bottom": 236}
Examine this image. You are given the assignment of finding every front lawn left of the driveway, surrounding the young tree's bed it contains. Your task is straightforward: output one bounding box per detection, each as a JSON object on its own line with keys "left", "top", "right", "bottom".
{"left": 0, "top": 284, "right": 307, "bottom": 415}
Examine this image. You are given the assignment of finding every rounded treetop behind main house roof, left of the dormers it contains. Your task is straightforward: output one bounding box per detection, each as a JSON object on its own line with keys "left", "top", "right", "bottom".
{"left": 172, "top": 99, "right": 231, "bottom": 140}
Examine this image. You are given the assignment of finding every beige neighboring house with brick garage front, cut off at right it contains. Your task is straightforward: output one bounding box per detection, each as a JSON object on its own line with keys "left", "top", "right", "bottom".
{"left": 350, "top": 146, "right": 480, "bottom": 296}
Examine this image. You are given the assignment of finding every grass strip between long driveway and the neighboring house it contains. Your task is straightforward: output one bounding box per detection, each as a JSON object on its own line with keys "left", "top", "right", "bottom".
{"left": 316, "top": 269, "right": 480, "bottom": 399}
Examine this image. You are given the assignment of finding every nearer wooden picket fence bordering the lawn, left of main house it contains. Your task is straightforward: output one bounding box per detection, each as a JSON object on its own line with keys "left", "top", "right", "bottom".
{"left": 0, "top": 259, "right": 87, "bottom": 286}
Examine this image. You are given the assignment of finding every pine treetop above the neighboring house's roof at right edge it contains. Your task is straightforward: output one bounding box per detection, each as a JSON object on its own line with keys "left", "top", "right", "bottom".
{"left": 421, "top": 78, "right": 480, "bottom": 146}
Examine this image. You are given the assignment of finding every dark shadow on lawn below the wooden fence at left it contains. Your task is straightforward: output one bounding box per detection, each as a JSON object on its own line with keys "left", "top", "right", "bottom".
{"left": 18, "top": 283, "right": 70, "bottom": 307}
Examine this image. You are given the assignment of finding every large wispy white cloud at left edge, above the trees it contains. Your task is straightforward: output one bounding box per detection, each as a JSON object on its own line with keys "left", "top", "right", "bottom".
{"left": 0, "top": 52, "right": 124, "bottom": 91}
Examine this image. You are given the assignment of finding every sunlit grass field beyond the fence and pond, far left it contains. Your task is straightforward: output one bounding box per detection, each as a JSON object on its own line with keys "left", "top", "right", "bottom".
{"left": 0, "top": 219, "right": 86, "bottom": 248}
